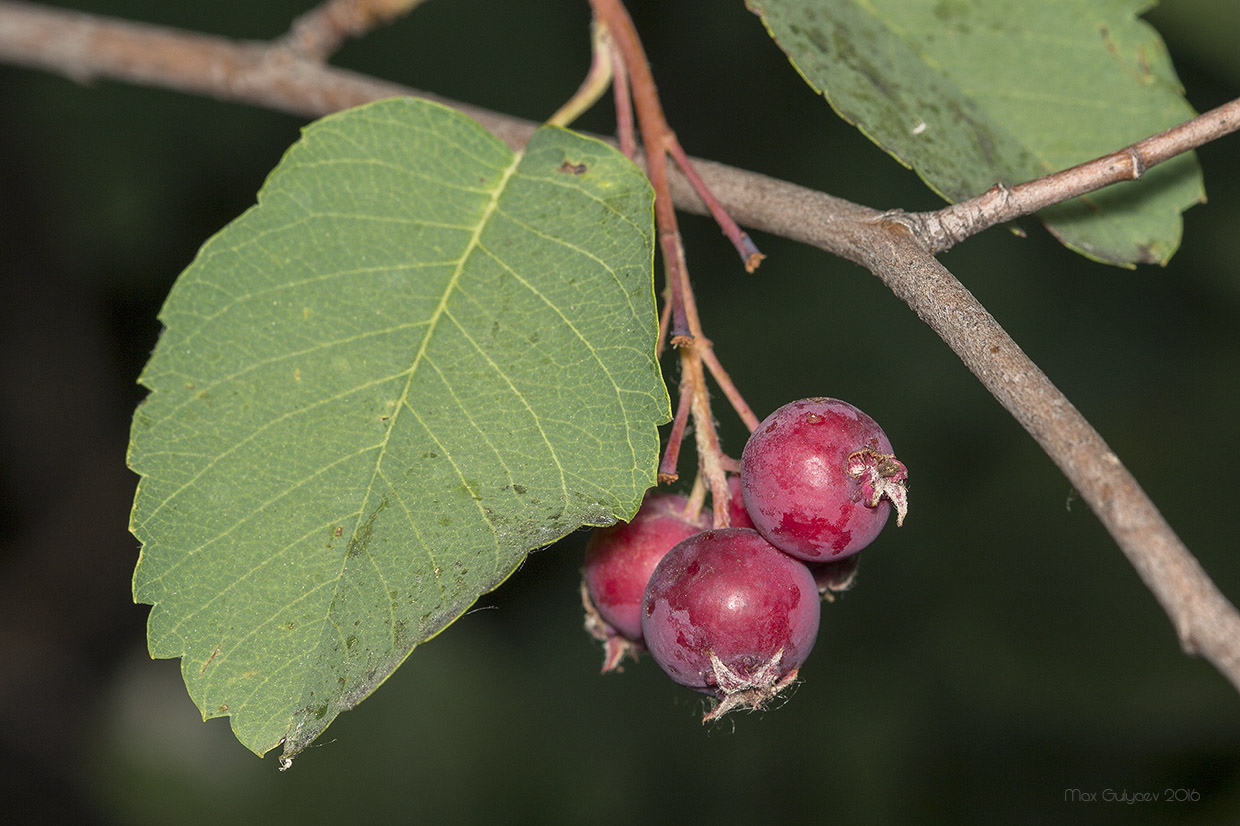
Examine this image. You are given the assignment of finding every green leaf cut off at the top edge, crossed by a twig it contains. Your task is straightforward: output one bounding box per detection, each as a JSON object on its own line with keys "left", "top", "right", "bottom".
{"left": 748, "top": 0, "right": 1205, "bottom": 265}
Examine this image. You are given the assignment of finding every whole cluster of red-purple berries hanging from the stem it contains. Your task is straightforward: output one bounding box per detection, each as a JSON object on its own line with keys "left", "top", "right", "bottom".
{"left": 582, "top": 398, "right": 908, "bottom": 719}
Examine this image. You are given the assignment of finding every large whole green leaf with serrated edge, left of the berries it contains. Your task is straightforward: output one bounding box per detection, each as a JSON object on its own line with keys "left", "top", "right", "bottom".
{"left": 129, "top": 99, "right": 670, "bottom": 758}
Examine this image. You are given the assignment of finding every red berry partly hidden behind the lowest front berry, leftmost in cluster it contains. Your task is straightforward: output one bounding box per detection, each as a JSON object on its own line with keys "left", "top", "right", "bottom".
{"left": 582, "top": 494, "right": 711, "bottom": 671}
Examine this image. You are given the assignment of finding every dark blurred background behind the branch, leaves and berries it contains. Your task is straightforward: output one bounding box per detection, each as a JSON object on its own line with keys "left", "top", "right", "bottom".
{"left": 0, "top": 0, "right": 1240, "bottom": 825}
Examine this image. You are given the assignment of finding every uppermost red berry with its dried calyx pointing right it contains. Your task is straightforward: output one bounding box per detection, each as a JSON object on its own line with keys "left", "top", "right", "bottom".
{"left": 740, "top": 398, "right": 908, "bottom": 562}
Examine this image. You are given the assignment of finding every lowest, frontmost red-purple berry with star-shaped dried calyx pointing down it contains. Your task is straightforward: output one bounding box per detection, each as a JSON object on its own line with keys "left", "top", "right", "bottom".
{"left": 641, "top": 528, "right": 821, "bottom": 722}
